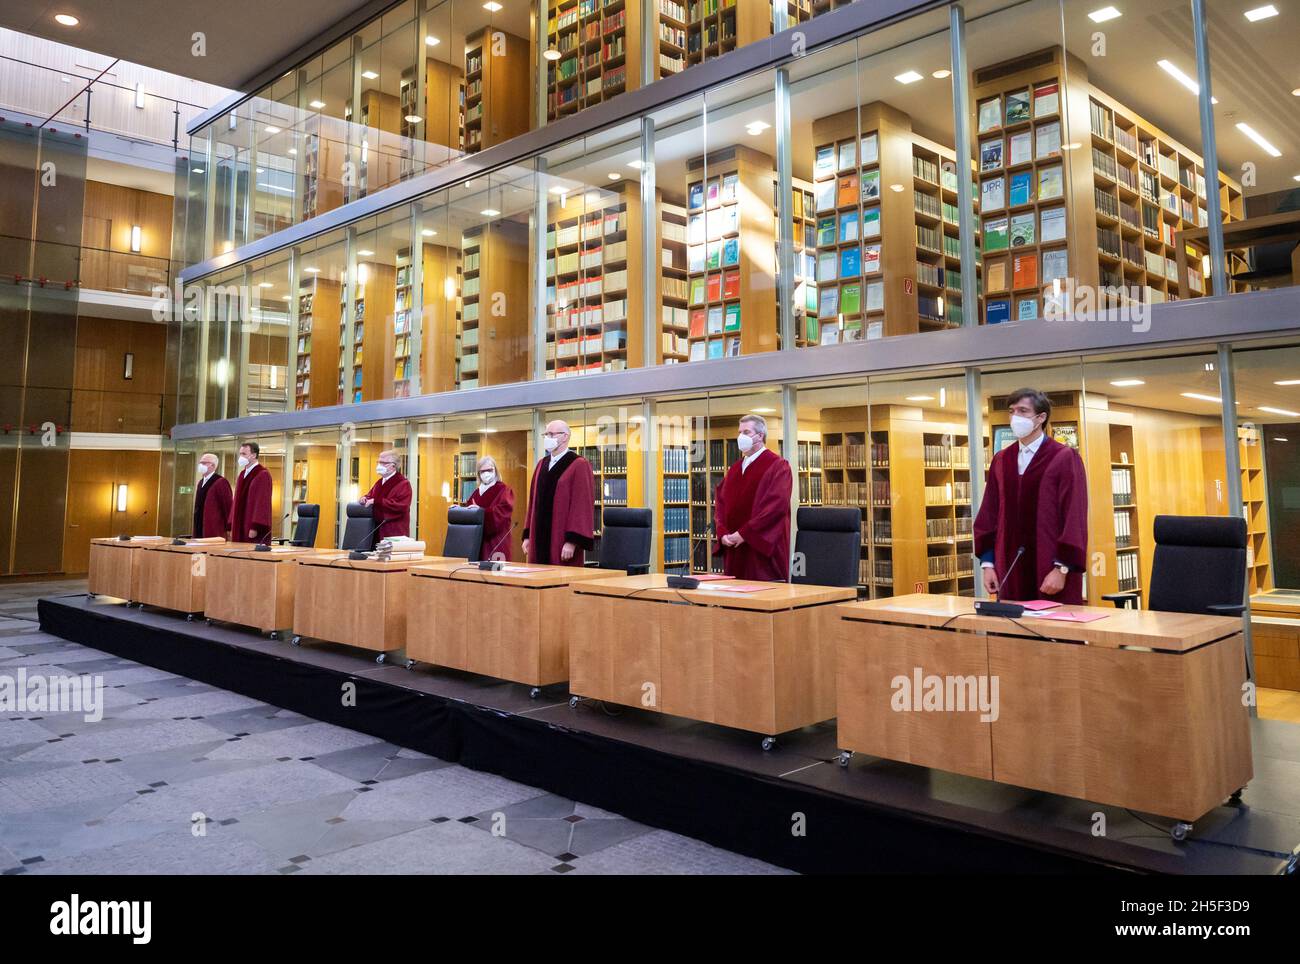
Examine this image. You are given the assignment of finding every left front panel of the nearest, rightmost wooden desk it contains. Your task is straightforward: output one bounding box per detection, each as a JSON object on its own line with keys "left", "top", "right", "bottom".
{"left": 836, "top": 620, "right": 993, "bottom": 780}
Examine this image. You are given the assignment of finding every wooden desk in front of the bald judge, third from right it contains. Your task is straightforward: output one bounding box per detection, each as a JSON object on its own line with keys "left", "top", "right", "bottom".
{"left": 407, "top": 561, "right": 620, "bottom": 696}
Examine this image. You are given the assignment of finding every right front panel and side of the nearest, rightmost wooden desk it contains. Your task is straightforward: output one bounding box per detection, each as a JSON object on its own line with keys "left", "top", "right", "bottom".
{"left": 988, "top": 634, "right": 1253, "bottom": 821}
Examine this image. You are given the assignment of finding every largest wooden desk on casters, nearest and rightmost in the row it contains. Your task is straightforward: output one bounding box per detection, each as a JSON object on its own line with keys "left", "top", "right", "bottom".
{"left": 836, "top": 595, "right": 1253, "bottom": 839}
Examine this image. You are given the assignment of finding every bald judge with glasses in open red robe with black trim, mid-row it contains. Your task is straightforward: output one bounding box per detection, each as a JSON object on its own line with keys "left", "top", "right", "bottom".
{"left": 524, "top": 421, "right": 595, "bottom": 566}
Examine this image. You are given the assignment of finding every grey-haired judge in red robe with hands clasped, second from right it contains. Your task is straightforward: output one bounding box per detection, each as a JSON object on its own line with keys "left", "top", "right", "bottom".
{"left": 714, "top": 414, "right": 794, "bottom": 582}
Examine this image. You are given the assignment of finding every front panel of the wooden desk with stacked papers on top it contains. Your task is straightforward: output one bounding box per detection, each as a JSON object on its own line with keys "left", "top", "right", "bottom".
{"left": 294, "top": 564, "right": 408, "bottom": 652}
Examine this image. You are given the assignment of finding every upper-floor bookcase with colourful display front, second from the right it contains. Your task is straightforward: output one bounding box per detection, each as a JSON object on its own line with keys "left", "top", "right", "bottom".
{"left": 801, "top": 101, "right": 974, "bottom": 344}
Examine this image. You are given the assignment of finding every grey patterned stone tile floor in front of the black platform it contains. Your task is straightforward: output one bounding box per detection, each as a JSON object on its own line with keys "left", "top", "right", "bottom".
{"left": 0, "top": 581, "right": 787, "bottom": 874}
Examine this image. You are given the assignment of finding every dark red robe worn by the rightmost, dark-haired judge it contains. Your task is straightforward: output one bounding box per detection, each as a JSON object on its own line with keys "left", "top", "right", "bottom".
{"left": 975, "top": 438, "right": 1088, "bottom": 605}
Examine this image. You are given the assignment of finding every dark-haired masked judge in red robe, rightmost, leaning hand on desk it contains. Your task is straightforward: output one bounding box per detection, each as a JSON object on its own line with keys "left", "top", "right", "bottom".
{"left": 975, "top": 388, "right": 1088, "bottom": 605}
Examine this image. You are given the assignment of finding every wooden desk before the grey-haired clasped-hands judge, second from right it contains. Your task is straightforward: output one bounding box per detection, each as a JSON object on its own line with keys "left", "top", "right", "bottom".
{"left": 569, "top": 573, "right": 857, "bottom": 750}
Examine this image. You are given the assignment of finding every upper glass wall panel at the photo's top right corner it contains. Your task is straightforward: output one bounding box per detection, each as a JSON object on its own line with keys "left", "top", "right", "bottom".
{"left": 1206, "top": 0, "right": 1300, "bottom": 294}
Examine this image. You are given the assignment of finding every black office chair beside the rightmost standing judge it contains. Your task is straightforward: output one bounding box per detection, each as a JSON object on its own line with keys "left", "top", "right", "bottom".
{"left": 1102, "top": 516, "right": 1245, "bottom": 616}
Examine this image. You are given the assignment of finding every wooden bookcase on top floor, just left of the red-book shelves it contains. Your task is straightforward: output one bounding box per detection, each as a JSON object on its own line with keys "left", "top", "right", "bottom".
{"left": 464, "top": 27, "right": 532, "bottom": 153}
